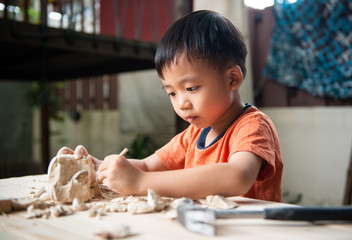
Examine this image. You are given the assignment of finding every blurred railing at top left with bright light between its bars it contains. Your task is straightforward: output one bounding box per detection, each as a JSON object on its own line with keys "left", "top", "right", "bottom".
{"left": 0, "top": 0, "right": 99, "bottom": 34}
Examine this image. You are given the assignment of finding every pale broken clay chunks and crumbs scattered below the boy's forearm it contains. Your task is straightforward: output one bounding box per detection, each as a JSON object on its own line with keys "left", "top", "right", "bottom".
{"left": 25, "top": 178, "right": 238, "bottom": 219}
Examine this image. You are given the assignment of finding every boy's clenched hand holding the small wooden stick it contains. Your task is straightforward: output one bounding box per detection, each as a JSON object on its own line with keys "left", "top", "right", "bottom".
{"left": 97, "top": 155, "right": 144, "bottom": 196}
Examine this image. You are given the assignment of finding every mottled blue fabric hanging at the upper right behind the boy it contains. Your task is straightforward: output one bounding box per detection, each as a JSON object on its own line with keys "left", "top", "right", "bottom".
{"left": 263, "top": 0, "right": 352, "bottom": 99}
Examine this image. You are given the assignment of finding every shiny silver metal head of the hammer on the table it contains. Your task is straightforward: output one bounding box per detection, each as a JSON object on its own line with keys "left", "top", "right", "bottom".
{"left": 177, "top": 198, "right": 216, "bottom": 236}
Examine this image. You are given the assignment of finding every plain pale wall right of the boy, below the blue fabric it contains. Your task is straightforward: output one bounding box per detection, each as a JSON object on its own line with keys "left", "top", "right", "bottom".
{"left": 262, "top": 107, "right": 352, "bottom": 205}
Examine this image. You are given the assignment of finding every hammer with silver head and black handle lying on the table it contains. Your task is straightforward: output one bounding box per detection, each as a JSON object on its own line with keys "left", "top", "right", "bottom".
{"left": 177, "top": 198, "right": 352, "bottom": 236}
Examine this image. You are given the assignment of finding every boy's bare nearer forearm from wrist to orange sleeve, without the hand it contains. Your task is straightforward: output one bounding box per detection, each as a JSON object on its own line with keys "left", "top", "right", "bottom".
{"left": 141, "top": 152, "right": 262, "bottom": 199}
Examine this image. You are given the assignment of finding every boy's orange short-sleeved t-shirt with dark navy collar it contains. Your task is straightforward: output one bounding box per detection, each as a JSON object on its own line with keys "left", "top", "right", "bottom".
{"left": 156, "top": 106, "right": 283, "bottom": 202}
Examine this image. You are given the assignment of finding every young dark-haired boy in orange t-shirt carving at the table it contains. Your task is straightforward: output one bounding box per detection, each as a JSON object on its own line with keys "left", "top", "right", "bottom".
{"left": 58, "top": 11, "right": 283, "bottom": 202}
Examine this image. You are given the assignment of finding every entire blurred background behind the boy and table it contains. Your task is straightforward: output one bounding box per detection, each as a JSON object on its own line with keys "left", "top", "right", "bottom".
{"left": 0, "top": 0, "right": 352, "bottom": 205}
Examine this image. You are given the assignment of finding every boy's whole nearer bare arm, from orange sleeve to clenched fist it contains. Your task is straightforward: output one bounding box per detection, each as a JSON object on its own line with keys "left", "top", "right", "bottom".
{"left": 98, "top": 152, "right": 262, "bottom": 199}
